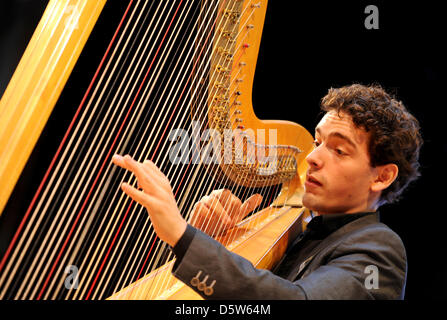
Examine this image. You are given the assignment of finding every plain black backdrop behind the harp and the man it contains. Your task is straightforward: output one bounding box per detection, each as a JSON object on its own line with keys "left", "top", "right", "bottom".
{"left": 0, "top": 0, "right": 447, "bottom": 301}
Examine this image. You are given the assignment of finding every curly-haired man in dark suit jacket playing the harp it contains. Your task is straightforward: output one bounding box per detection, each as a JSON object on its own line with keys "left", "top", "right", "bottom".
{"left": 113, "top": 84, "right": 422, "bottom": 299}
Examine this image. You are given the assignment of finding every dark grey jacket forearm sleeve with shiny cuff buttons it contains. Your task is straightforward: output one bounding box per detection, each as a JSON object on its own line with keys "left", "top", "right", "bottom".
{"left": 172, "top": 225, "right": 312, "bottom": 300}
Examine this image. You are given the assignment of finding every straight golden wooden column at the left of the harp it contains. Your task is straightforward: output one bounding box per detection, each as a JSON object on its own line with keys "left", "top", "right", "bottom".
{"left": 0, "top": 0, "right": 106, "bottom": 214}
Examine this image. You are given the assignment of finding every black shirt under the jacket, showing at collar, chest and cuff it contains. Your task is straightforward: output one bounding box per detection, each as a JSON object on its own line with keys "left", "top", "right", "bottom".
{"left": 173, "top": 212, "right": 379, "bottom": 281}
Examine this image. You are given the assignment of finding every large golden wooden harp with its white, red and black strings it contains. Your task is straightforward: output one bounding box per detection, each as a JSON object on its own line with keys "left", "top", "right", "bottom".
{"left": 0, "top": 0, "right": 313, "bottom": 299}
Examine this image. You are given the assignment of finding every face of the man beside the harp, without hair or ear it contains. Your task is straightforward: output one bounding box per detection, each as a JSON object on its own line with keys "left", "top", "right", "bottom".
{"left": 303, "top": 111, "right": 376, "bottom": 214}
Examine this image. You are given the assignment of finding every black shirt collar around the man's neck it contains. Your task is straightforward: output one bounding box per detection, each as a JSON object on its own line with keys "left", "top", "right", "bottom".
{"left": 307, "top": 211, "right": 380, "bottom": 238}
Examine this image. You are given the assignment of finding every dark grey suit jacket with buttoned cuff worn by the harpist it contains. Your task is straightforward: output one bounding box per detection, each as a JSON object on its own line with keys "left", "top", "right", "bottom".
{"left": 173, "top": 214, "right": 407, "bottom": 300}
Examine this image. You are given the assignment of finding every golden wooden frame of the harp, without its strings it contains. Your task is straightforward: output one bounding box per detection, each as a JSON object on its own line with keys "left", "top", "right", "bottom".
{"left": 0, "top": 0, "right": 313, "bottom": 299}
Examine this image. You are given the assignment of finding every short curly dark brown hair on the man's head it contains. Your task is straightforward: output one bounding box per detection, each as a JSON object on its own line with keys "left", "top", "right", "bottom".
{"left": 321, "top": 84, "right": 423, "bottom": 205}
